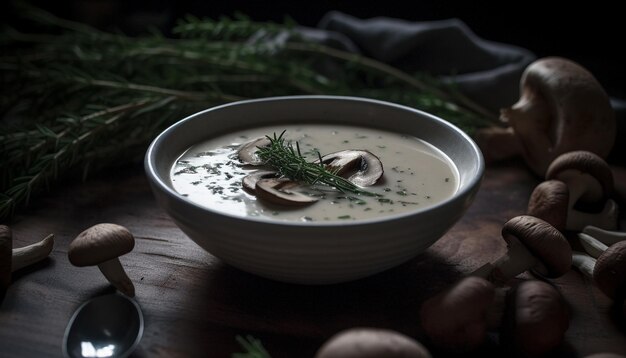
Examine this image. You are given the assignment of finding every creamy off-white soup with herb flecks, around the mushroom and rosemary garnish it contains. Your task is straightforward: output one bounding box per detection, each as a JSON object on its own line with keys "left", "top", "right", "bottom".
{"left": 171, "top": 124, "right": 458, "bottom": 222}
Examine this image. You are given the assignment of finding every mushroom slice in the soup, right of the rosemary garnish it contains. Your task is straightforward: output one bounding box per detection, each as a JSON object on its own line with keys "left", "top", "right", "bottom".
{"left": 317, "top": 149, "right": 384, "bottom": 186}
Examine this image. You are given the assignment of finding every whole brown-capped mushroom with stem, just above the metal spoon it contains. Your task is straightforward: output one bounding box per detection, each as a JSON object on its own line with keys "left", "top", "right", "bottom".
{"left": 67, "top": 223, "right": 135, "bottom": 297}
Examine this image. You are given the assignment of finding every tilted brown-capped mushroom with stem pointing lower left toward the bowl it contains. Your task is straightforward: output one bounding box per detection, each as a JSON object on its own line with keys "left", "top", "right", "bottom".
{"left": 472, "top": 215, "right": 572, "bottom": 285}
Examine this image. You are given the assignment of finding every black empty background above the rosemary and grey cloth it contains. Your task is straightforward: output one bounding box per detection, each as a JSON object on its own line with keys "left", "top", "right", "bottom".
{"left": 3, "top": 0, "right": 626, "bottom": 99}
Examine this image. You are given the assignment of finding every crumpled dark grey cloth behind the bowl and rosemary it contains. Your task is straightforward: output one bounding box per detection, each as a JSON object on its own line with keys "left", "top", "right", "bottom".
{"left": 305, "top": 11, "right": 535, "bottom": 112}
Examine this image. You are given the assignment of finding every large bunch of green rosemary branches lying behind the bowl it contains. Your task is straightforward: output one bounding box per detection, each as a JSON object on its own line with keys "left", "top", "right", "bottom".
{"left": 0, "top": 4, "right": 493, "bottom": 221}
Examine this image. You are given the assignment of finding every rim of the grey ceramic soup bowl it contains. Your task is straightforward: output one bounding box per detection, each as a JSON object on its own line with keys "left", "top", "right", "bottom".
{"left": 144, "top": 95, "right": 485, "bottom": 228}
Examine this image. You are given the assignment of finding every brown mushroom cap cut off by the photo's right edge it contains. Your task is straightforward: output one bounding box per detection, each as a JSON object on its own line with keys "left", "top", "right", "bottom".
{"left": 593, "top": 241, "right": 626, "bottom": 300}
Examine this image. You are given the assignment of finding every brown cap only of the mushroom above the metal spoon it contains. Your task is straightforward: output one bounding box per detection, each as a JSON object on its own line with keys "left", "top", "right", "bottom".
{"left": 67, "top": 223, "right": 135, "bottom": 267}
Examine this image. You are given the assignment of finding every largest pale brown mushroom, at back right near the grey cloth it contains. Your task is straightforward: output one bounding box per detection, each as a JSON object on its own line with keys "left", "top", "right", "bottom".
{"left": 501, "top": 57, "right": 616, "bottom": 176}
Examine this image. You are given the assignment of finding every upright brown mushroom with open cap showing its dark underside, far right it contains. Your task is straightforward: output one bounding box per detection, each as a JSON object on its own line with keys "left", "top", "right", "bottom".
{"left": 546, "top": 151, "right": 617, "bottom": 231}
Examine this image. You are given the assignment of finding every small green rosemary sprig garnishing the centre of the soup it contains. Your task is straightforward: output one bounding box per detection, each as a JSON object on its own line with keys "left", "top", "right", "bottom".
{"left": 257, "top": 131, "right": 377, "bottom": 196}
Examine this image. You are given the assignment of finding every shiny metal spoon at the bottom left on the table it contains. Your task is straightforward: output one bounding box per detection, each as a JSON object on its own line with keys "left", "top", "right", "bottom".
{"left": 63, "top": 293, "right": 143, "bottom": 358}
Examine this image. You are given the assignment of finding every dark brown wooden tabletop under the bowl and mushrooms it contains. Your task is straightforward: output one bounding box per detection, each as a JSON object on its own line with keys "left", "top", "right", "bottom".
{"left": 0, "top": 163, "right": 626, "bottom": 358}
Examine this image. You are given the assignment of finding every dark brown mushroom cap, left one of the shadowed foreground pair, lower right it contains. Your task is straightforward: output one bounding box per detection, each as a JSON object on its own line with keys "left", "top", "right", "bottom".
{"left": 420, "top": 276, "right": 495, "bottom": 352}
